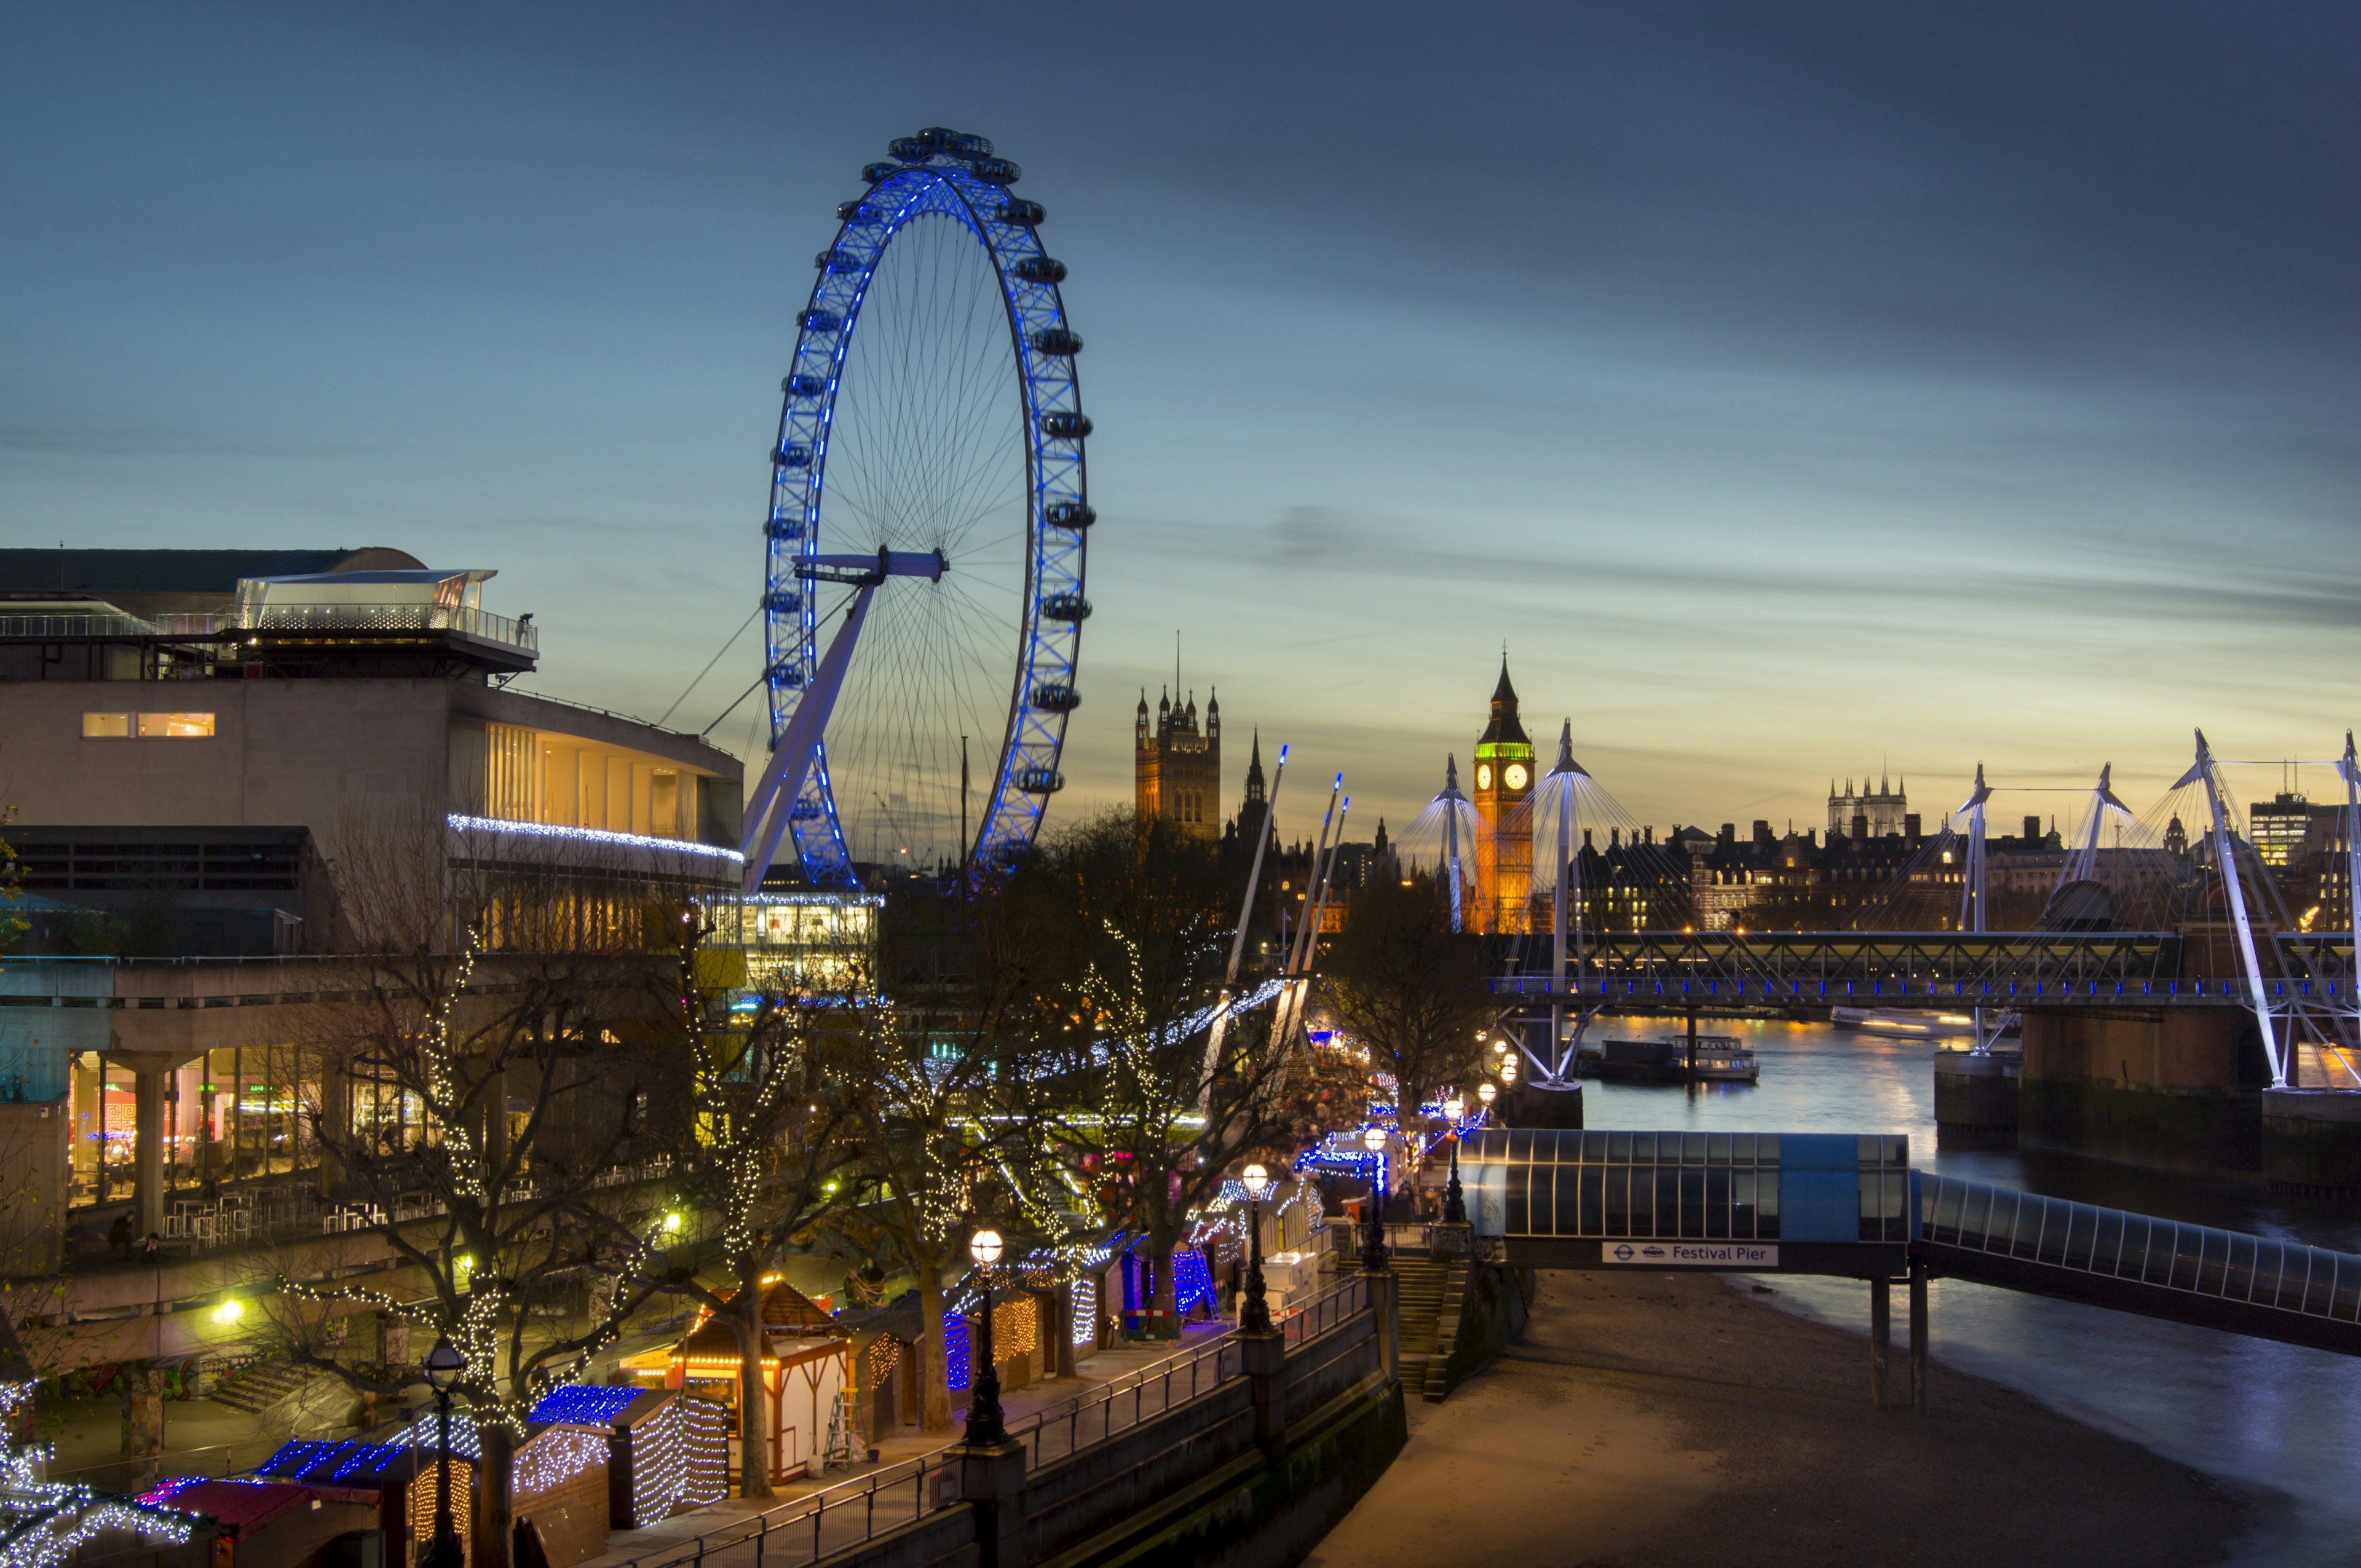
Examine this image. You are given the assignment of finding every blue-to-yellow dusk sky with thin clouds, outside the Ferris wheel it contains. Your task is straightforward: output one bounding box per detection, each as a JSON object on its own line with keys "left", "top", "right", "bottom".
{"left": 0, "top": 2, "right": 2361, "bottom": 836}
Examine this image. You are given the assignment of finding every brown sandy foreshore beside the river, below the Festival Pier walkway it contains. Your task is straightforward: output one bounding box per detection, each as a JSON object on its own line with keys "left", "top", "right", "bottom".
{"left": 1310, "top": 1273, "right": 2271, "bottom": 1568}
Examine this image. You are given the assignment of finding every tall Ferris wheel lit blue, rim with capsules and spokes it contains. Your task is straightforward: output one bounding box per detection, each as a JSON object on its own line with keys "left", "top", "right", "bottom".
{"left": 762, "top": 132, "right": 1091, "bottom": 886}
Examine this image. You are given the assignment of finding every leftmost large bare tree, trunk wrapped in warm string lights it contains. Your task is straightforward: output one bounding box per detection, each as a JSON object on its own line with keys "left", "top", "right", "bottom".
{"left": 281, "top": 822, "right": 678, "bottom": 1568}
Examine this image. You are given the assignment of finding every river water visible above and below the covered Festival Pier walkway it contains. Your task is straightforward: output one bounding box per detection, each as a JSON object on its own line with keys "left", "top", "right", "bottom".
{"left": 1584, "top": 1018, "right": 2361, "bottom": 1563}
